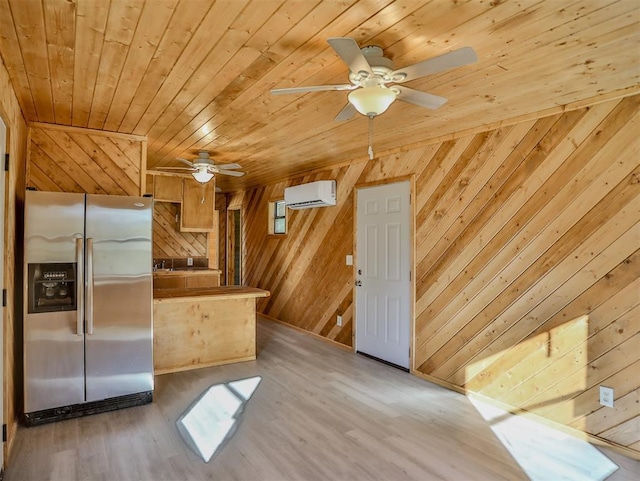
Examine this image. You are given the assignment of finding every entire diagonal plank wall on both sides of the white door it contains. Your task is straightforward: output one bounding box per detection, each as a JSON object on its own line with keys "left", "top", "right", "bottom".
{"left": 243, "top": 96, "right": 640, "bottom": 456}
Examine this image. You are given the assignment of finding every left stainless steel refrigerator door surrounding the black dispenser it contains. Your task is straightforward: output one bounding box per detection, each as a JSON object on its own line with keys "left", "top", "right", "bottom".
{"left": 23, "top": 191, "right": 84, "bottom": 413}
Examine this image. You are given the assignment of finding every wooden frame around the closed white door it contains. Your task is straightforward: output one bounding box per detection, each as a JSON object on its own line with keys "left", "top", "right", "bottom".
{"left": 351, "top": 174, "right": 416, "bottom": 374}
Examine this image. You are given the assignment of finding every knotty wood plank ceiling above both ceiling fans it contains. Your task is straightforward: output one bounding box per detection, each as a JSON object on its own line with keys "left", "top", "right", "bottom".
{"left": 0, "top": 0, "right": 640, "bottom": 190}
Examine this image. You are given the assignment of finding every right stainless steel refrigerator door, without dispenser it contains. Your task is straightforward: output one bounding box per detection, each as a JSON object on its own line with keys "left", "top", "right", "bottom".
{"left": 85, "top": 195, "right": 153, "bottom": 401}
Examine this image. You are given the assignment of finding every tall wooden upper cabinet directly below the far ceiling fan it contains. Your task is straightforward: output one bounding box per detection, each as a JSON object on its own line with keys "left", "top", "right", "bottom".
{"left": 181, "top": 178, "right": 216, "bottom": 232}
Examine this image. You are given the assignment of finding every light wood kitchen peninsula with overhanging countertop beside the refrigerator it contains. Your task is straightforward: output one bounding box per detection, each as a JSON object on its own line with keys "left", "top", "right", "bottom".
{"left": 153, "top": 286, "right": 269, "bottom": 374}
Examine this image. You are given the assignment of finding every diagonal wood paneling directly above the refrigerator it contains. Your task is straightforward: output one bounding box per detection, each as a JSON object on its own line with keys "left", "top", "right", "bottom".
{"left": 27, "top": 124, "right": 146, "bottom": 196}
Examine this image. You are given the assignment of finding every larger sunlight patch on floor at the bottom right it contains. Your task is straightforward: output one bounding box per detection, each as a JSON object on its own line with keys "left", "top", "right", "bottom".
{"left": 469, "top": 397, "right": 618, "bottom": 481}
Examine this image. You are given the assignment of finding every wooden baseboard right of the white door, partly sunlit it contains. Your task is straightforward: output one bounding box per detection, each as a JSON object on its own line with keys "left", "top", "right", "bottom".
{"left": 411, "top": 370, "right": 640, "bottom": 461}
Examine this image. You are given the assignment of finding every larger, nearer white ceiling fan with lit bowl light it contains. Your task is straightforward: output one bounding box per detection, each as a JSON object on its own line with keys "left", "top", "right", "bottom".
{"left": 271, "top": 37, "right": 478, "bottom": 120}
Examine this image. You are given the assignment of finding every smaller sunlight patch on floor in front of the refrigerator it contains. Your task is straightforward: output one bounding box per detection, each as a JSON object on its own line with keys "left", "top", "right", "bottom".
{"left": 176, "top": 376, "right": 262, "bottom": 463}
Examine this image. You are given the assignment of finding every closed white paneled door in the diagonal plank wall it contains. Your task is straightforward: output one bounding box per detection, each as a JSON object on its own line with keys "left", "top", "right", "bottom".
{"left": 355, "top": 181, "right": 411, "bottom": 369}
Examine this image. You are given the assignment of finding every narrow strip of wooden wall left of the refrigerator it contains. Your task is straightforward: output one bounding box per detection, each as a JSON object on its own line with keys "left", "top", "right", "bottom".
{"left": 0, "top": 54, "right": 27, "bottom": 464}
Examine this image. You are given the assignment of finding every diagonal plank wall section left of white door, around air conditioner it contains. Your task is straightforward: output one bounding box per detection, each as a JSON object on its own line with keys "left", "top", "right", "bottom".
{"left": 243, "top": 174, "right": 356, "bottom": 346}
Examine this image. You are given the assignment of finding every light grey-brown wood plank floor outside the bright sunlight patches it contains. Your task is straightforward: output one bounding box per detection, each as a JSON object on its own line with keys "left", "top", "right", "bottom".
{"left": 4, "top": 320, "right": 640, "bottom": 481}
